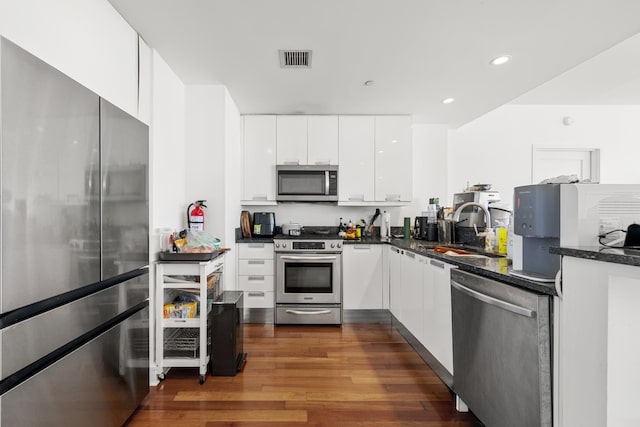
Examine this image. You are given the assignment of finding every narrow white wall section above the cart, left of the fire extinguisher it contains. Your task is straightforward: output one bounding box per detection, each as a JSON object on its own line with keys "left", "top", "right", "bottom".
{"left": 150, "top": 51, "right": 186, "bottom": 259}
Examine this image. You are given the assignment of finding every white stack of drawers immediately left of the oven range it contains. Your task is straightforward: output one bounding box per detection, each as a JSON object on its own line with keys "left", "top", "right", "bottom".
{"left": 237, "top": 243, "right": 274, "bottom": 308}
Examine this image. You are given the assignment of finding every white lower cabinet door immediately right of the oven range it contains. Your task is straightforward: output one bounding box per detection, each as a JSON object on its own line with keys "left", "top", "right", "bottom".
{"left": 342, "top": 244, "right": 383, "bottom": 310}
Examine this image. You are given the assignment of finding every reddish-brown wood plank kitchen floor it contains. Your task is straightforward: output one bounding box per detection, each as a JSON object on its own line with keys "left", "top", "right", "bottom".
{"left": 128, "top": 324, "right": 480, "bottom": 427}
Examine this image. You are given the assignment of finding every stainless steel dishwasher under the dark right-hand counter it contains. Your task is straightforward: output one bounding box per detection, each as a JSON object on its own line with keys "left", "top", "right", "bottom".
{"left": 451, "top": 270, "right": 552, "bottom": 427}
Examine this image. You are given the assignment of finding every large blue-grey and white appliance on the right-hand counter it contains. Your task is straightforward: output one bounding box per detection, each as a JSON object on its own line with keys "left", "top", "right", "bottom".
{"left": 510, "top": 183, "right": 640, "bottom": 286}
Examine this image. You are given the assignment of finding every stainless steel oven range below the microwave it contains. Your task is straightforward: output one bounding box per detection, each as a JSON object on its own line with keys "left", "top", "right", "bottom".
{"left": 274, "top": 234, "right": 342, "bottom": 325}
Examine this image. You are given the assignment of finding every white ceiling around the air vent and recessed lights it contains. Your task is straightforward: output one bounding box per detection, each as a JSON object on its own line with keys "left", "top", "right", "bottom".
{"left": 109, "top": 0, "right": 640, "bottom": 127}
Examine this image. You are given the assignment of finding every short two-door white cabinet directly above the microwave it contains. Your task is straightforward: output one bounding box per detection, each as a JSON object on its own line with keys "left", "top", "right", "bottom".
{"left": 277, "top": 116, "right": 338, "bottom": 165}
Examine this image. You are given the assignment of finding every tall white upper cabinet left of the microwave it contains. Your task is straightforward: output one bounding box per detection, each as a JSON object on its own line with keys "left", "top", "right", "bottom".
{"left": 242, "top": 115, "right": 276, "bottom": 204}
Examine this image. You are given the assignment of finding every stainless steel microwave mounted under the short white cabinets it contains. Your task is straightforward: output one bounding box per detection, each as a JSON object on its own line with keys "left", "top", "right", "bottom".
{"left": 276, "top": 165, "right": 338, "bottom": 202}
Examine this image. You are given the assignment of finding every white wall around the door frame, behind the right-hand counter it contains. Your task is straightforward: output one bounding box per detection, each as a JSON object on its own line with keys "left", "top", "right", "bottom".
{"left": 447, "top": 105, "right": 640, "bottom": 203}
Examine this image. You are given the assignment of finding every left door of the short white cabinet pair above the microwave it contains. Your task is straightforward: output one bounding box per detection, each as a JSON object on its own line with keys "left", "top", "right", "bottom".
{"left": 277, "top": 116, "right": 307, "bottom": 165}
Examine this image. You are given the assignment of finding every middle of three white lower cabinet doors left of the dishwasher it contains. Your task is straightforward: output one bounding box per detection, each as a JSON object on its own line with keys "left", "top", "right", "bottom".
{"left": 400, "top": 251, "right": 426, "bottom": 339}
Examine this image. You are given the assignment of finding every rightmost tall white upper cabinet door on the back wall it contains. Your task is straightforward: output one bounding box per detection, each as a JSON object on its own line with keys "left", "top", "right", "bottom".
{"left": 375, "top": 116, "right": 412, "bottom": 202}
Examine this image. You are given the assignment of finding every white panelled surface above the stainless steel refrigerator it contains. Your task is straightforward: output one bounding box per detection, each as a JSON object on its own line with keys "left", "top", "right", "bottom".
{"left": 0, "top": 0, "right": 138, "bottom": 117}
